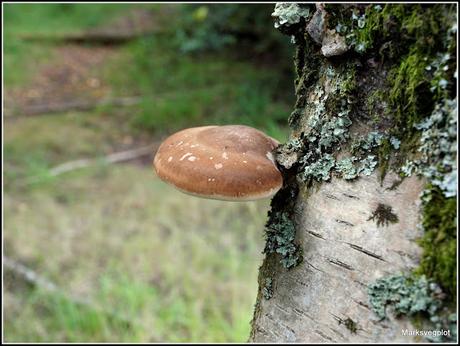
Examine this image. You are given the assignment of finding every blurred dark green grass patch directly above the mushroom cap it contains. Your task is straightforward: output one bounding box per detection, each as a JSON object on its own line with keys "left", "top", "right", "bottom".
{"left": 105, "top": 32, "right": 293, "bottom": 141}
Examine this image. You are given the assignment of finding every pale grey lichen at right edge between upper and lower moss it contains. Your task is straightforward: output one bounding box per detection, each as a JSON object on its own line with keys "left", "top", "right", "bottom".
{"left": 401, "top": 99, "right": 457, "bottom": 197}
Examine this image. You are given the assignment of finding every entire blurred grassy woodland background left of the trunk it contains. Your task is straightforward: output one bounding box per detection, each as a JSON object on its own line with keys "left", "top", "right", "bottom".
{"left": 3, "top": 4, "right": 294, "bottom": 342}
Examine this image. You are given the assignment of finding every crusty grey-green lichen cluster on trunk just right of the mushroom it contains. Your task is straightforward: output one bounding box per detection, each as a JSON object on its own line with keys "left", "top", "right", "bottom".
{"left": 292, "top": 59, "right": 390, "bottom": 182}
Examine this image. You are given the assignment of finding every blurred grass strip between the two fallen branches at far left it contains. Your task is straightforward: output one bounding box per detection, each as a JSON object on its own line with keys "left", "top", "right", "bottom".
{"left": 3, "top": 112, "right": 139, "bottom": 184}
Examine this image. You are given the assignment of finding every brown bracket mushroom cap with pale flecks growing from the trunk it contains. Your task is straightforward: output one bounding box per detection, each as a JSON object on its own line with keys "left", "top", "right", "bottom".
{"left": 153, "top": 125, "right": 283, "bottom": 201}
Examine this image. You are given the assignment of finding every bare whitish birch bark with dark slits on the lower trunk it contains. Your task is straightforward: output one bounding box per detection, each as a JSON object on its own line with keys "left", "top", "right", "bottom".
{"left": 250, "top": 172, "right": 424, "bottom": 343}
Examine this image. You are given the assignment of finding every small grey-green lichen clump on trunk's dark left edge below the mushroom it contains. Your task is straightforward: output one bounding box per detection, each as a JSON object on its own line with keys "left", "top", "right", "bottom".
{"left": 264, "top": 212, "right": 302, "bottom": 269}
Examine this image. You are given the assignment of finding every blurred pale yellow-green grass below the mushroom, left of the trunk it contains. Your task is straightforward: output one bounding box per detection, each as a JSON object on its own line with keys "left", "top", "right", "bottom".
{"left": 4, "top": 166, "right": 268, "bottom": 342}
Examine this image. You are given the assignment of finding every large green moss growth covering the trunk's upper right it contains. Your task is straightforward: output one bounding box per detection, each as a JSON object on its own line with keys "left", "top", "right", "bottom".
{"left": 326, "top": 4, "right": 456, "bottom": 180}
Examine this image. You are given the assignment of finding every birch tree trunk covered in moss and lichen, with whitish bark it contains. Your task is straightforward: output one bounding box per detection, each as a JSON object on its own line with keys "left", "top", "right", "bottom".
{"left": 250, "top": 3, "right": 457, "bottom": 343}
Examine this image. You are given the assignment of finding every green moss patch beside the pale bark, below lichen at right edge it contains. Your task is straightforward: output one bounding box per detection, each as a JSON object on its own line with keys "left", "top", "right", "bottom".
{"left": 416, "top": 185, "right": 457, "bottom": 301}
